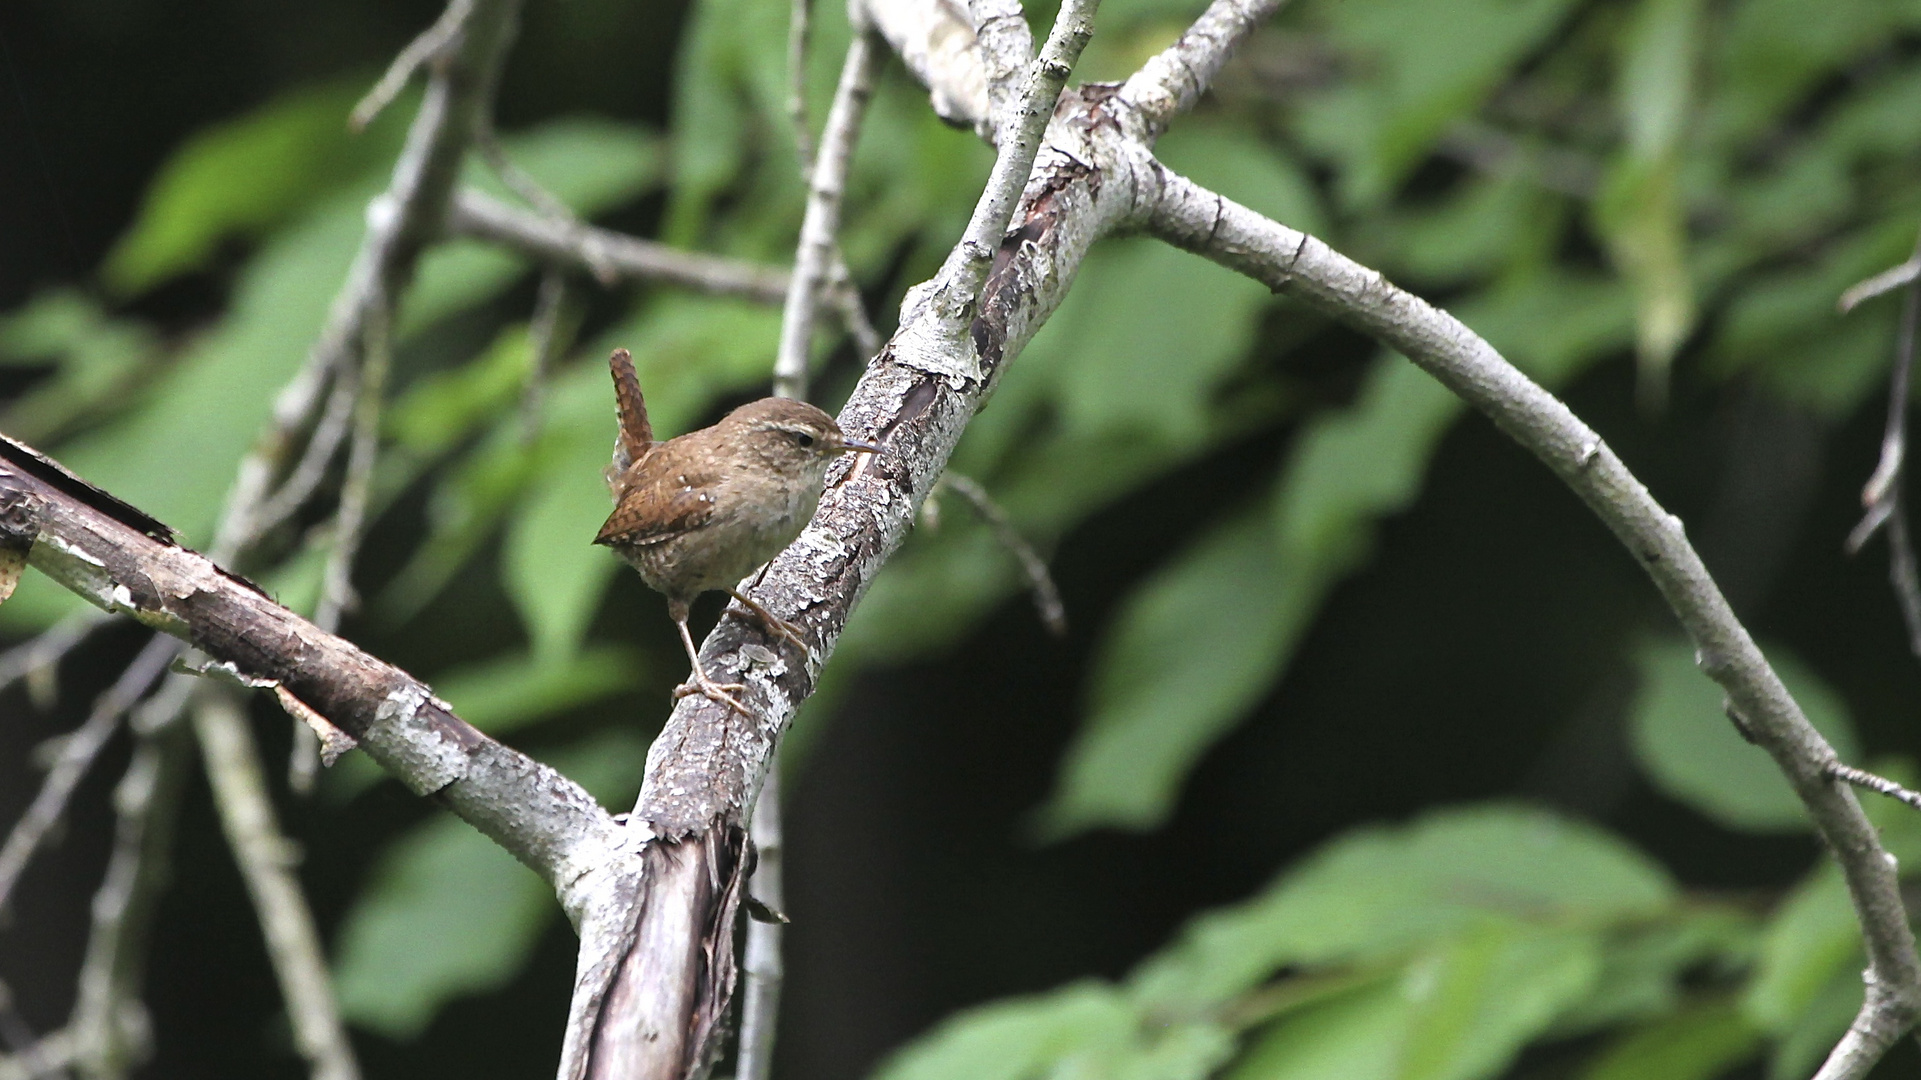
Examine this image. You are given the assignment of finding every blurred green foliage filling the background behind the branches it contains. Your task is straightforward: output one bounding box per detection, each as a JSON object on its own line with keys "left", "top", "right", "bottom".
{"left": 0, "top": 0, "right": 1921, "bottom": 1080}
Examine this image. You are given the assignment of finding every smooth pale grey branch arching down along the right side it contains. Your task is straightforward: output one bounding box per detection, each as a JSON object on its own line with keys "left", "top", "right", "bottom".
{"left": 1143, "top": 169, "right": 1921, "bottom": 1080}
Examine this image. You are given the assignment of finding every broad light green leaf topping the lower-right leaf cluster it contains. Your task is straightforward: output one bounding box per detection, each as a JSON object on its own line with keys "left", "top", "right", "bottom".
{"left": 1133, "top": 805, "right": 1675, "bottom": 1013}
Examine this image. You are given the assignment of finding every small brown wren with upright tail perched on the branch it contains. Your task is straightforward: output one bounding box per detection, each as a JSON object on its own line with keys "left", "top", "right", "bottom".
{"left": 594, "top": 348, "right": 880, "bottom": 713}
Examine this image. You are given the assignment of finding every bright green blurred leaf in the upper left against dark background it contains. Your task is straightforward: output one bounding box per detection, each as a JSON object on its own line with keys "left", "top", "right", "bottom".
{"left": 100, "top": 77, "right": 411, "bottom": 294}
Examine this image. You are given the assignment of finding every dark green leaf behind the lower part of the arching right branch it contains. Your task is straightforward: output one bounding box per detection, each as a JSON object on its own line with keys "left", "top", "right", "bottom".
{"left": 1631, "top": 640, "right": 1856, "bottom": 832}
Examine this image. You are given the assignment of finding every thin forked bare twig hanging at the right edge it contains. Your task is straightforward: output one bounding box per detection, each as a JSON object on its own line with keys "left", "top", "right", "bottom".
{"left": 1842, "top": 227, "right": 1921, "bottom": 657}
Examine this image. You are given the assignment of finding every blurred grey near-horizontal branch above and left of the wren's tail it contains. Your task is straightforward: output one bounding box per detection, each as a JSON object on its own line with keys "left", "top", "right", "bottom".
{"left": 448, "top": 190, "right": 788, "bottom": 304}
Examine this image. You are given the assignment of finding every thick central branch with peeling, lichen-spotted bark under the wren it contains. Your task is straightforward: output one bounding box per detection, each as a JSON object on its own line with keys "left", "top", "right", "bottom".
{"left": 561, "top": 4, "right": 1133, "bottom": 1080}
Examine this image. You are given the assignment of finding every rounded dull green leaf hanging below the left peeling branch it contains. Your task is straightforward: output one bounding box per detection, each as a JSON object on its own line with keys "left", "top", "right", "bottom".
{"left": 334, "top": 817, "right": 557, "bottom": 1040}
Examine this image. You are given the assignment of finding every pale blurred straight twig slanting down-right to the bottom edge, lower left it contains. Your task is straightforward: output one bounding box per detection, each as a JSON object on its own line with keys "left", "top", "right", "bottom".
{"left": 192, "top": 686, "right": 359, "bottom": 1080}
